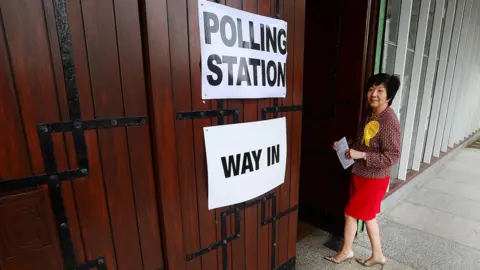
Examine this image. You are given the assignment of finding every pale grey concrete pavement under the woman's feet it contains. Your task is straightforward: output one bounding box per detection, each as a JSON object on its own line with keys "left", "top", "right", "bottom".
{"left": 296, "top": 148, "right": 480, "bottom": 270}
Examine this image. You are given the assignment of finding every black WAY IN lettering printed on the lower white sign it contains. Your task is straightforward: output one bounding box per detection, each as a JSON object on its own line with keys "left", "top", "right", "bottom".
{"left": 221, "top": 144, "right": 280, "bottom": 178}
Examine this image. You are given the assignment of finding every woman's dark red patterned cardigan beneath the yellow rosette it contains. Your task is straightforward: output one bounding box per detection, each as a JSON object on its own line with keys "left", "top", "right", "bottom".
{"left": 352, "top": 107, "right": 401, "bottom": 178}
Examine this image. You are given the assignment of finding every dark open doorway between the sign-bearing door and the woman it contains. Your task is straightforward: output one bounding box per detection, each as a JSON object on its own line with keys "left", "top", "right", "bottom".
{"left": 299, "top": 0, "right": 377, "bottom": 237}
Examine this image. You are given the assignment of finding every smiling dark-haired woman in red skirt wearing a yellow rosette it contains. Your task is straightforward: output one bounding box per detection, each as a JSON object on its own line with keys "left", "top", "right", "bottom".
{"left": 326, "top": 73, "right": 401, "bottom": 267}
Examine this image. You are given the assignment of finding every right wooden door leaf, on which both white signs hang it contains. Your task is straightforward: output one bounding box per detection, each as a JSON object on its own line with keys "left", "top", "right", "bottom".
{"left": 143, "top": 0, "right": 305, "bottom": 270}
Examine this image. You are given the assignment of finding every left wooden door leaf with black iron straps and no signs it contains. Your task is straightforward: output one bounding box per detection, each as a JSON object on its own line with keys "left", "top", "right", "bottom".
{"left": 0, "top": 0, "right": 164, "bottom": 270}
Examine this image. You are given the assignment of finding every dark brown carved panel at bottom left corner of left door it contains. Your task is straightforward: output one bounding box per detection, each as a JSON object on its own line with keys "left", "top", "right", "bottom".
{"left": 0, "top": 189, "right": 63, "bottom": 270}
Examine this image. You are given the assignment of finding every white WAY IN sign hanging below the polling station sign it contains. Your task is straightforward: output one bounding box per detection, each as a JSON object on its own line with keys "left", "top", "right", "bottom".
{"left": 204, "top": 117, "right": 287, "bottom": 210}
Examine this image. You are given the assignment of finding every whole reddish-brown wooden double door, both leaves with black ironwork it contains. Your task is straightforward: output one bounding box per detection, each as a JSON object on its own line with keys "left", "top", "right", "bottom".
{"left": 0, "top": 0, "right": 305, "bottom": 270}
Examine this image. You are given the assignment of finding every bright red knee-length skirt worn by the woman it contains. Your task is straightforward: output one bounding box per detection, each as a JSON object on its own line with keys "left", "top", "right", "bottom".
{"left": 345, "top": 174, "right": 390, "bottom": 221}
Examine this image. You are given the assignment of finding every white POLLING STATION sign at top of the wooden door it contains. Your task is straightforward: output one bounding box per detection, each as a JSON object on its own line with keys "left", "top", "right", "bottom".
{"left": 198, "top": 0, "right": 287, "bottom": 99}
